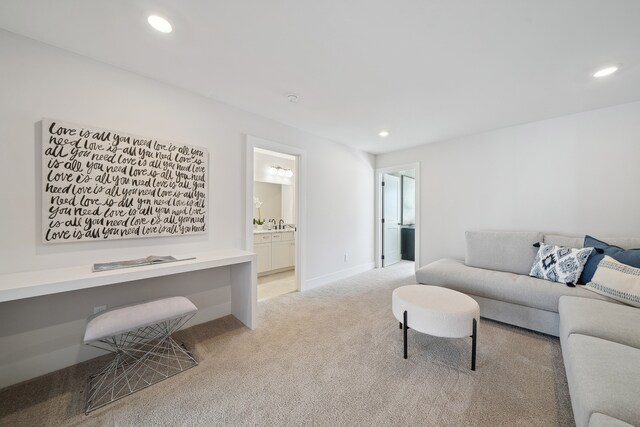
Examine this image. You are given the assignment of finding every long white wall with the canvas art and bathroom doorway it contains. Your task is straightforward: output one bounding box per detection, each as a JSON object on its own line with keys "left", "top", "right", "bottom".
{"left": 0, "top": 31, "right": 374, "bottom": 387}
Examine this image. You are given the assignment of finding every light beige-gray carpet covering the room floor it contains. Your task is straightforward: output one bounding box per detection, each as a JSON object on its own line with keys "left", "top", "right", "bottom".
{"left": 0, "top": 264, "right": 573, "bottom": 426}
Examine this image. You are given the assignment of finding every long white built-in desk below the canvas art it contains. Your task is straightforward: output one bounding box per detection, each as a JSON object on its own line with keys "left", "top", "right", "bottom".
{"left": 0, "top": 249, "right": 257, "bottom": 329}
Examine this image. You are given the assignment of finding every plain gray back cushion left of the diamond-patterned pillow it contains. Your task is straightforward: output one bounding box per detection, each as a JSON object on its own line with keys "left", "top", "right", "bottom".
{"left": 465, "top": 231, "right": 542, "bottom": 274}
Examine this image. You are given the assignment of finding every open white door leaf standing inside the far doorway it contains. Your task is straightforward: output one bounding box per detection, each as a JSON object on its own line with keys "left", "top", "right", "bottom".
{"left": 382, "top": 173, "right": 401, "bottom": 267}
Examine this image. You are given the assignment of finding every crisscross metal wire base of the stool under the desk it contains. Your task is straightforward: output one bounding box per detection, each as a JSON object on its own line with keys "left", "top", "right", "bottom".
{"left": 85, "top": 313, "right": 198, "bottom": 414}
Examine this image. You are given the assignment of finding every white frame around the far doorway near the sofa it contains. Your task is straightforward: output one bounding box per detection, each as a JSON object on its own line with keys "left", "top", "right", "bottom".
{"left": 374, "top": 162, "right": 421, "bottom": 270}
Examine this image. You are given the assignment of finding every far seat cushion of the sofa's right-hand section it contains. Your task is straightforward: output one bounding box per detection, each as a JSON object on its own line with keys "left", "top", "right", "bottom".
{"left": 558, "top": 296, "right": 640, "bottom": 349}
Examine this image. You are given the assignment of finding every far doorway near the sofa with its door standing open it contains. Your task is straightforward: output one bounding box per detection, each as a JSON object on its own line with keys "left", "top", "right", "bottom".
{"left": 376, "top": 164, "right": 420, "bottom": 268}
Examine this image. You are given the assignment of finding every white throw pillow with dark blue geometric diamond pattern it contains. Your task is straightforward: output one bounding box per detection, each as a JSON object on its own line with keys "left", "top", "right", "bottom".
{"left": 529, "top": 243, "right": 593, "bottom": 284}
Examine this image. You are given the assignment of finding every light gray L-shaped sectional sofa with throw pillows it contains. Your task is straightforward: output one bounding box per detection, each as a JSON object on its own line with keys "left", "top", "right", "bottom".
{"left": 416, "top": 231, "right": 640, "bottom": 427}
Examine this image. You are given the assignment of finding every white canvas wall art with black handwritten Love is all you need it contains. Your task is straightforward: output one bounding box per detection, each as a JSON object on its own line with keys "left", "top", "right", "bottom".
{"left": 42, "top": 119, "right": 209, "bottom": 243}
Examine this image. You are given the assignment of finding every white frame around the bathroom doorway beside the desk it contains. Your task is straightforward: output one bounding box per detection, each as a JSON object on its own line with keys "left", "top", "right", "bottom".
{"left": 244, "top": 135, "right": 307, "bottom": 291}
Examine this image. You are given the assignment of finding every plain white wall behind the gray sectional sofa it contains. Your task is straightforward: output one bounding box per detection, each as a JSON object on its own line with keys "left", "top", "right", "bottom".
{"left": 376, "top": 102, "right": 640, "bottom": 265}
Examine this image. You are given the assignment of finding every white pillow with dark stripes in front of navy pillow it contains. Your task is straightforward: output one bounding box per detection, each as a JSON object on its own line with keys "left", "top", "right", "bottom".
{"left": 585, "top": 255, "right": 640, "bottom": 307}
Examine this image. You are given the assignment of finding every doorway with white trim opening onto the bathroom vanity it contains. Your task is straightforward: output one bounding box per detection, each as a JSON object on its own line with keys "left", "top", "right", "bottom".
{"left": 246, "top": 136, "right": 303, "bottom": 301}
